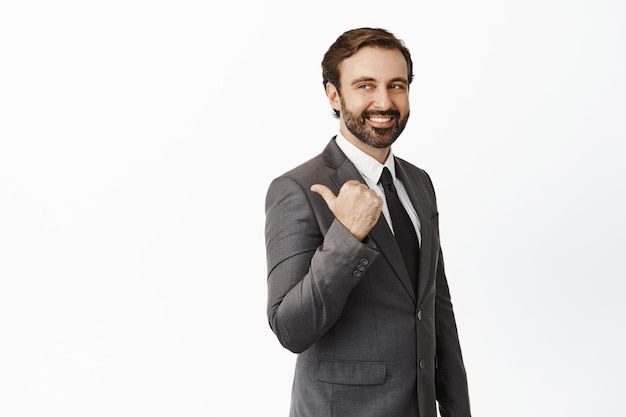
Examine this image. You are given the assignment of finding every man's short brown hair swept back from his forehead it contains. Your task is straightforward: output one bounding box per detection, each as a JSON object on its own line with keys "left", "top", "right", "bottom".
{"left": 322, "top": 28, "right": 413, "bottom": 117}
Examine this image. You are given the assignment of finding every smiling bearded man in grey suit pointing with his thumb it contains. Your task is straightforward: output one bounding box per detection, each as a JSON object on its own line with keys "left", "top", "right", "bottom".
{"left": 265, "top": 28, "right": 470, "bottom": 417}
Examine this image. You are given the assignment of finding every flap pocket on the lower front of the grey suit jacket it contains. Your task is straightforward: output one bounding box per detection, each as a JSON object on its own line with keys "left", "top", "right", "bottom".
{"left": 316, "top": 360, "right": 387, "bottom": 385}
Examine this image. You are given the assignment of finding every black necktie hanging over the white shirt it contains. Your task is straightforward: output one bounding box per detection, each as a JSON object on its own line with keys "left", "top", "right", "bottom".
{"left": 380, "top": 167, "right": 419, "bottom": 290}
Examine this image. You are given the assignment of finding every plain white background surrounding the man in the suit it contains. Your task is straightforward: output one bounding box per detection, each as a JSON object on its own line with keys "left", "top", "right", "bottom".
{"left": 0, "top": 0, "right": 626, "bottom": 417}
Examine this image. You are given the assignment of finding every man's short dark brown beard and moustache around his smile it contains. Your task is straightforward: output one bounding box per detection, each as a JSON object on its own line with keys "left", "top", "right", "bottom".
{"left": 341, "top": 98, "right": 409, "bottom": 149}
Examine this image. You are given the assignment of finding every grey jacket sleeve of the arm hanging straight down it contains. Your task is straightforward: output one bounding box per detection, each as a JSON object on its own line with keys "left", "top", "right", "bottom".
{"left": 435, "top": 249, "right": 471, "bottom": 417}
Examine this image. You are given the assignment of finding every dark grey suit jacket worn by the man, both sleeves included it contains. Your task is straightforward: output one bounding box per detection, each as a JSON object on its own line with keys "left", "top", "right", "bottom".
{"left": 265, "top": 138, "right": 470, "bottom": 417}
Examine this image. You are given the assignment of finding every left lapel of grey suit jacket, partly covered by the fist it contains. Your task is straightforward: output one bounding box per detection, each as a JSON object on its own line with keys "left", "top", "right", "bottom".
{"left": 324, "top": 138, "right": 416, "bottom": 302}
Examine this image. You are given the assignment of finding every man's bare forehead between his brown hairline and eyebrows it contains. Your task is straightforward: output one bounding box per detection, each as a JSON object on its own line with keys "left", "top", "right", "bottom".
{"left": 339, "top": 46, "right": 409, "bottom": 85}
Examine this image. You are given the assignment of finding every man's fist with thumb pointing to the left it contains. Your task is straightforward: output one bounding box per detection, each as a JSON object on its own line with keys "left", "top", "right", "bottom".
{"left": 311, "top": 180, "right": 383, "bottom": 240}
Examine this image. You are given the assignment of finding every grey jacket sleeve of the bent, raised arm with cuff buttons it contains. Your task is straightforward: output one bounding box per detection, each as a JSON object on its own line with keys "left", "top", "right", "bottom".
{"left": 265, "top": 177, "right": 378, "bottom": 353}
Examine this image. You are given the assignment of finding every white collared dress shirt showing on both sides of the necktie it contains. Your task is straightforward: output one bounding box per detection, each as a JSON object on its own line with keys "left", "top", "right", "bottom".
{"left": 335, "top": 132, "right": 422, "bottom": 247}
